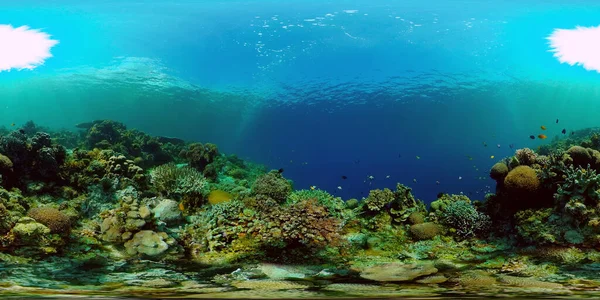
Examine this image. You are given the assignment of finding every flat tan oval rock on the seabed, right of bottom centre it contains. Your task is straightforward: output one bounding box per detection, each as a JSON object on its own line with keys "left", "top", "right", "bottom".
{"left": 360, "top": 262, "right": 438, "bottom": 282}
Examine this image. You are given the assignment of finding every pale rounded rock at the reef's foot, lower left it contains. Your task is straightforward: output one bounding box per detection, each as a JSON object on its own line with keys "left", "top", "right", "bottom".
{"left": 125, "top": 230, "right": 173, "bottom": 256}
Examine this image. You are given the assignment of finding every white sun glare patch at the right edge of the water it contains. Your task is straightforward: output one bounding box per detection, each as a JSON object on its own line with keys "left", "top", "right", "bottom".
{"left": 547, "top": 26, "right": 600, "bottom": 72}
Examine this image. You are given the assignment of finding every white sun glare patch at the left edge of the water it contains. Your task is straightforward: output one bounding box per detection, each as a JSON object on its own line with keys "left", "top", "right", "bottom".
{"left": 0, "top": 24, "right": 58, "bottom": 72}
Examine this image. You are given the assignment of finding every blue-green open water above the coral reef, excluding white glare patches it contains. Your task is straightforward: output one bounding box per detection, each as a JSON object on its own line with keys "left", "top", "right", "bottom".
{"left": 0, "top": 0, "right": 600, "bottom": 202}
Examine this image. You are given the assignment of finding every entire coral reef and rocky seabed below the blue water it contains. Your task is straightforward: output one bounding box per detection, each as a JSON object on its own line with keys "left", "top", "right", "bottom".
{"left": 0, "top": 120, "right": 600, "bottom": 299}
